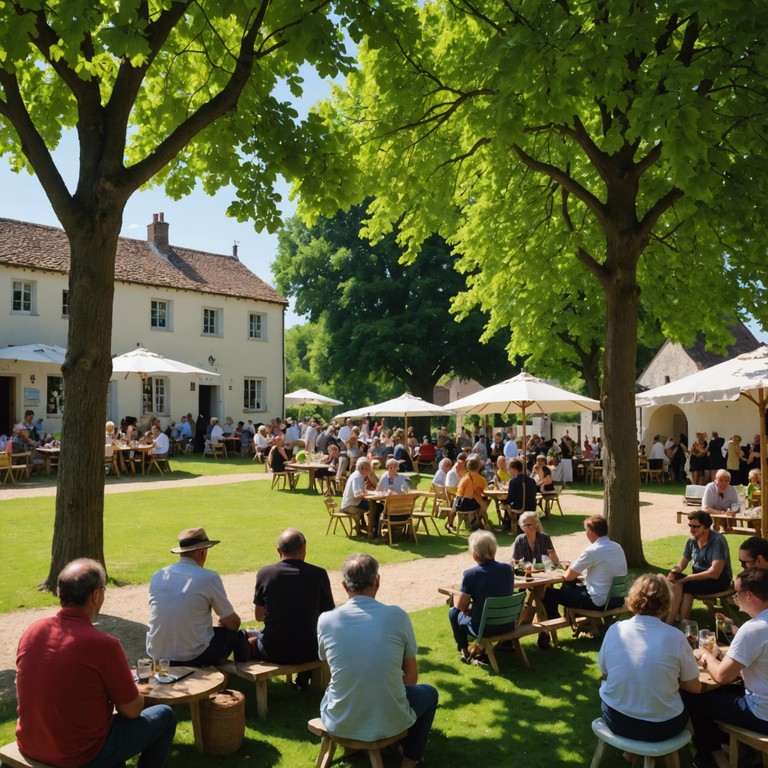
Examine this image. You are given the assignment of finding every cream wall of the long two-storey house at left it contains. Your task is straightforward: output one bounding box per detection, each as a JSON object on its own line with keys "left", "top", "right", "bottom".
{"left": 0, "top": 266, "right": 283, "bottom": 432}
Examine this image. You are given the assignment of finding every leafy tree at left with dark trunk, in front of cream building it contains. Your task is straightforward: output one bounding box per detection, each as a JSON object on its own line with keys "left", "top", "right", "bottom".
{"left": 0, "top": 0, "right": 404, "bottom": 589}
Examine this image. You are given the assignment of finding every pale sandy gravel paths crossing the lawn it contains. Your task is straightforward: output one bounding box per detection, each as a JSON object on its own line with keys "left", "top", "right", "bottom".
{"left": 0, "top": 475, "right": 684, "bottom": 698}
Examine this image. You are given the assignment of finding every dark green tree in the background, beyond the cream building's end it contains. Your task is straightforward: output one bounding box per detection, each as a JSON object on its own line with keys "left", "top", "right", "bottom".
{"left": 273, "top": 205, "right": 512, "bottom": 405}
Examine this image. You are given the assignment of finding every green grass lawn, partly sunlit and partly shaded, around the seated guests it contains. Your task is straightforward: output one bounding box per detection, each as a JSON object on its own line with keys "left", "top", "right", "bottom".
{"left": 0, "top": 464, "right": 738, "bottom": 768}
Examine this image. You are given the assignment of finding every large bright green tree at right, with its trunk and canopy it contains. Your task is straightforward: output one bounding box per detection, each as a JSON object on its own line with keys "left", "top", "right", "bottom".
{"left": 298, "top": 0, "right": 768, "bottom": 565}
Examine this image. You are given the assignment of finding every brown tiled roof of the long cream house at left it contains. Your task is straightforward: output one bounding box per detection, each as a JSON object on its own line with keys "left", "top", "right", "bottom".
{"left": 0, "top": 218, "right": 288, "bottom": 304}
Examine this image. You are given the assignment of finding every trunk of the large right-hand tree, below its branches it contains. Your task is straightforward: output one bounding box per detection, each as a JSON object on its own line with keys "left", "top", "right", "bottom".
{"left": 600, "top": 249, "right": 646, "bottom": 568}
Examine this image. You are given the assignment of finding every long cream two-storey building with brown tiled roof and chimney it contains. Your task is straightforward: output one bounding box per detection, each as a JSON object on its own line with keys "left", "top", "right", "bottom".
{"left": 0, "top": 214, "right": 287, "bottom": 433}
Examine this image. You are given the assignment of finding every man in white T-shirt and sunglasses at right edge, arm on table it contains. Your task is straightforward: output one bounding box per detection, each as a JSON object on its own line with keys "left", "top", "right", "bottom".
{"left": 681, "top": 568, "right": 768, "bottom": 768}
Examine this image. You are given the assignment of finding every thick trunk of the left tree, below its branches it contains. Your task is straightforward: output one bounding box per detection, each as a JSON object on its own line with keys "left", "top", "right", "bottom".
{"left": 44, "top": 211, "right": 122, "bottom": 591}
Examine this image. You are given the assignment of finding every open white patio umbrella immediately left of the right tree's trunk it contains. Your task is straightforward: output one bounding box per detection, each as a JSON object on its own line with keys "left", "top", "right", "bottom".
{"left": 445, "top": 371, "right": 600, "bottom": 462}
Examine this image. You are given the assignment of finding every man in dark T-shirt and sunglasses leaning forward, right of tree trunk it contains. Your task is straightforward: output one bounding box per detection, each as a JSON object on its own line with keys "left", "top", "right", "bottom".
{"left": 667, "top": 510, "right": 732, "bottom": 624}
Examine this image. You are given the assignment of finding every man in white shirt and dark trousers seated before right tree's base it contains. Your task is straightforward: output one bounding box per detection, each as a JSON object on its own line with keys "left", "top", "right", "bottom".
{"left": 539, "top": 515, "right": 627, "bottom": 648}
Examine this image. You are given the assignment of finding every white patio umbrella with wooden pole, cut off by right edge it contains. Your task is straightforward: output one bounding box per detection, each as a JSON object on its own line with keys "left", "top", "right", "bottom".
{"left": 635, "top": 346, "right": 768, "bottom": 531}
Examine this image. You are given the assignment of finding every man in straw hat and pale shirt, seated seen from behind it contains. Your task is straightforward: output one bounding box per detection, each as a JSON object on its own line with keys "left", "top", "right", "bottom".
{"left": 147, "top": 528, "right": 247, "bottom": 667}
